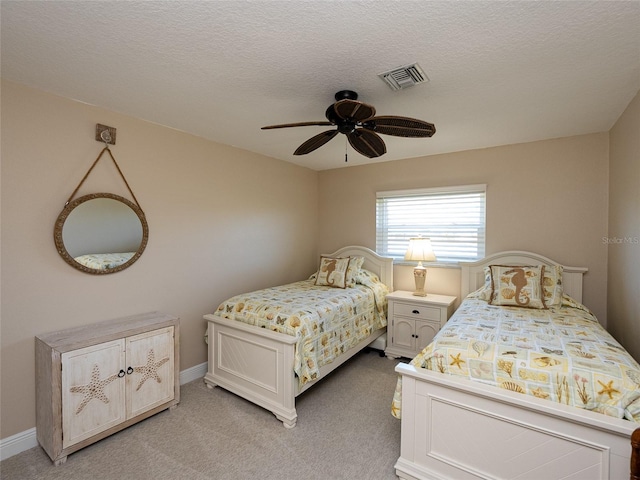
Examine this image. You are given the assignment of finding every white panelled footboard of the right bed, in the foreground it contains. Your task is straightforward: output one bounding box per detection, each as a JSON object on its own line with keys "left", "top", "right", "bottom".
{"left": 395, "top": 364, "right": 637, "bottom": 480}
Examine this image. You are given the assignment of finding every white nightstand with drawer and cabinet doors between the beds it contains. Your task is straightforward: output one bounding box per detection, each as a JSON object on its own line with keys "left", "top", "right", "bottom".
{"left": 384, "top": 290, "right": 456, "bottom": 358}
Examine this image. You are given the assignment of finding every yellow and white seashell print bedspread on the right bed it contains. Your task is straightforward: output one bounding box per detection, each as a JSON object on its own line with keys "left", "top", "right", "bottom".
{"left": 392, "top": 294, "right": 640, "bottom": 423}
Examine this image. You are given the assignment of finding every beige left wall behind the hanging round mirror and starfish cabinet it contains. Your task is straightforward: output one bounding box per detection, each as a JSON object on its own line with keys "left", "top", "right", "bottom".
{"left": 0, "top": 82, "right": 318, "bottom": 438}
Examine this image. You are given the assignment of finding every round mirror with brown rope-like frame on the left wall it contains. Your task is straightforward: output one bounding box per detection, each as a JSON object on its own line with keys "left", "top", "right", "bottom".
{"left": 53, "top": 193, "right": 149, "bottom": 275}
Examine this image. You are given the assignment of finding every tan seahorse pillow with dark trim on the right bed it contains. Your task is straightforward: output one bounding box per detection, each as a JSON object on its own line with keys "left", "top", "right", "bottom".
{"left": 489, "top": 265, "right": 547, "bottom": 308}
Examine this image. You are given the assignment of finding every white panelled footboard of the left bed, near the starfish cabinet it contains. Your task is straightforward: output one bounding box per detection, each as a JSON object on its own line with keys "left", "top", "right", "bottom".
{"left": 204, "top": 315, "right": 298, "bottom": 428}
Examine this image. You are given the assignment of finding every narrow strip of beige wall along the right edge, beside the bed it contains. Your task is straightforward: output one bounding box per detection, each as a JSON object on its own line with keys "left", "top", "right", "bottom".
{"left": 607, "top": 92, "right": 640, "bottom": 360}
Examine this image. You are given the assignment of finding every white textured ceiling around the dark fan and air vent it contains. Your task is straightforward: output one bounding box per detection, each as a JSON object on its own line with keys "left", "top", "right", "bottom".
{"left": 0, "top": 0, "right": 640, "bottom": 170}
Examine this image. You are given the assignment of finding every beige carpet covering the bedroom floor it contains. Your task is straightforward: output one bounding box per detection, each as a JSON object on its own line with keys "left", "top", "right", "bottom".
{"left": 0, "top": 351, "right": 400, "bottom": 480}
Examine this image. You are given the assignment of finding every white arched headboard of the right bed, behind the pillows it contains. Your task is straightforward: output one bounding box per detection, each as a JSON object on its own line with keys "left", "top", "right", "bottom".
{"left": 460, "top": 250, "right": 588, "bottom": 303}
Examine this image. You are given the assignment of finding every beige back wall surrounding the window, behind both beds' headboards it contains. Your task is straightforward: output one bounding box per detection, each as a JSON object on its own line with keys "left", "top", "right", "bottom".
{"left": 319, "top": 133, "right": 609, "bottom": 318}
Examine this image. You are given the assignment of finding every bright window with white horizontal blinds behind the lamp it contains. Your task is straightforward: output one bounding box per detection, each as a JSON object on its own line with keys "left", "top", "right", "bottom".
{"left": 376, "top": 185, "right": 487, "bottom": 263}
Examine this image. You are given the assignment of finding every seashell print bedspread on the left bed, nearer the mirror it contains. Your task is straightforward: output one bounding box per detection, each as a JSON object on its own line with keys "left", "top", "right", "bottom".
{"left": 214, "top": 277, "right": 388, "bottom": 386}
